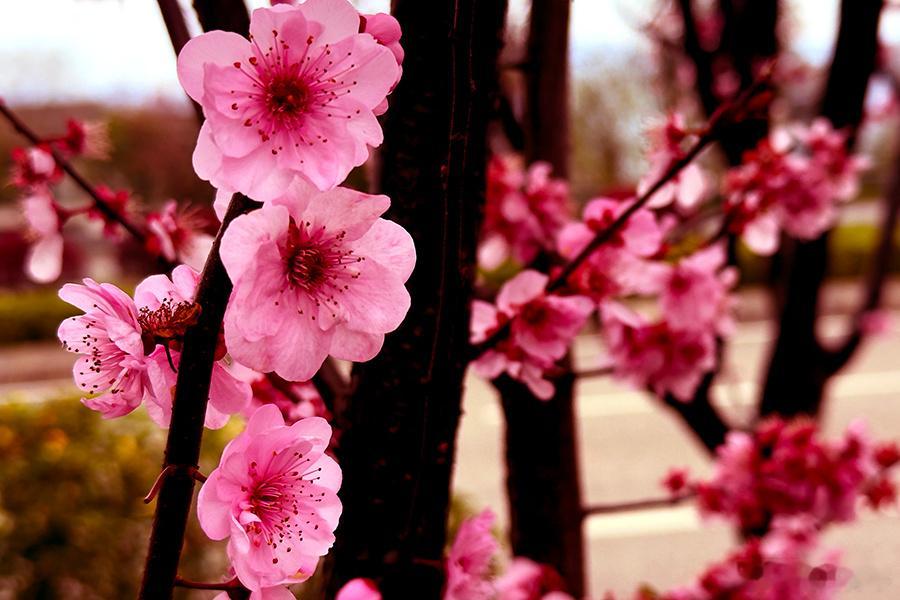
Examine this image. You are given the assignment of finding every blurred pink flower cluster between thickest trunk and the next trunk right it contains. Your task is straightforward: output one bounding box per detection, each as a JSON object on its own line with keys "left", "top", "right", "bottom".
{"left": 478, "top": 155, "right": 571, "bottom": 270}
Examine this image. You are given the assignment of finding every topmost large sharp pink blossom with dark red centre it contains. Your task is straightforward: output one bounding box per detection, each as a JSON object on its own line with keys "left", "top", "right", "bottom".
{"left": 178, "top": 0, "right": 399, "bottom": 197}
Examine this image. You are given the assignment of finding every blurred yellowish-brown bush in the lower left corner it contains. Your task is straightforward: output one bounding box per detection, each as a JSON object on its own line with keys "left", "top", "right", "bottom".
{"left": 0, "top": 397, "right": 242, "bottom": 600}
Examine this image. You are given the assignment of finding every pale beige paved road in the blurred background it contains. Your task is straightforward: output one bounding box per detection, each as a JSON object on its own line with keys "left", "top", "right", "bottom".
{"left": 7, "top": 288, "right": 900, "bottom": 600}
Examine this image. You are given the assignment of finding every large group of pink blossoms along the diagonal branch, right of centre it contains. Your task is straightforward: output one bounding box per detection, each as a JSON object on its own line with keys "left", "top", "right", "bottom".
{"left": 471, "top": 145, "right": 737, "bottom": 401}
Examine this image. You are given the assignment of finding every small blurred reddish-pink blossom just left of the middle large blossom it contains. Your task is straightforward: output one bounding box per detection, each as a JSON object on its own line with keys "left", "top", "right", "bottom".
{"left": 147, "top": 200, "right": 213, "bottom": 270}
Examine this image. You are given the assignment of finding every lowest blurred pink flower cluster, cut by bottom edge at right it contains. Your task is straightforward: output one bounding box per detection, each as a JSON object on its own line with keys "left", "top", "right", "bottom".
{"left": 652, "top": 516, "right": 848, "bottom": 600}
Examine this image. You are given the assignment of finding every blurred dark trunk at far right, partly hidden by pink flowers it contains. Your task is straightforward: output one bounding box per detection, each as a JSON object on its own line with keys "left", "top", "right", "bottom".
{"left": 759, "top": 0, "right": 884, "bottom": 417}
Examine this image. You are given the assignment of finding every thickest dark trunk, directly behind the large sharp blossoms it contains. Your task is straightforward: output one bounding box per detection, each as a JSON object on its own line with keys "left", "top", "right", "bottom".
{"left": 330, "top": 0, "right": 506, "bottom": 600}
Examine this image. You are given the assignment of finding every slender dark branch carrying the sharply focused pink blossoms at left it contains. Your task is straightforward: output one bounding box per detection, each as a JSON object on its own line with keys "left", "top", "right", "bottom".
{"left": 140, "top": 194, "right": 259, "bottom": 600}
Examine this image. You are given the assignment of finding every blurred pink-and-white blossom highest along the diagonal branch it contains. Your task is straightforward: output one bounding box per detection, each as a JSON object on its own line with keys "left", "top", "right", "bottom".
{"left": 637, "top": 113, "right": 708, "bottom": 210}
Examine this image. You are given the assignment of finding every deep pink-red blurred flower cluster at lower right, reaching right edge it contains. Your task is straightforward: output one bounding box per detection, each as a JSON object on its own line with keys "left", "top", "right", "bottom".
{"left": 667, "top": 418, "right": 900, "bottom": 531}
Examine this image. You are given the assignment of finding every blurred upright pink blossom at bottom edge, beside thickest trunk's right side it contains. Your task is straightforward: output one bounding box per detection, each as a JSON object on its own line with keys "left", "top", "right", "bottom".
{"left": 444, "top": 509, "right": 499, "bottom": 600}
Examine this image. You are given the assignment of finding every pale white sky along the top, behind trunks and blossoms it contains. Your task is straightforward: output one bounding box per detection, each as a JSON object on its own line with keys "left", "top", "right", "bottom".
{"left": 0, "top": 0, "right": 900, "bottom": 104}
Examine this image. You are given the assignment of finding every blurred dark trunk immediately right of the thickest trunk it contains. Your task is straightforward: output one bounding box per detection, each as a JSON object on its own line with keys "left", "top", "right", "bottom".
{"left": 494, "top": 0, "right": 584, "bottom": 597}
